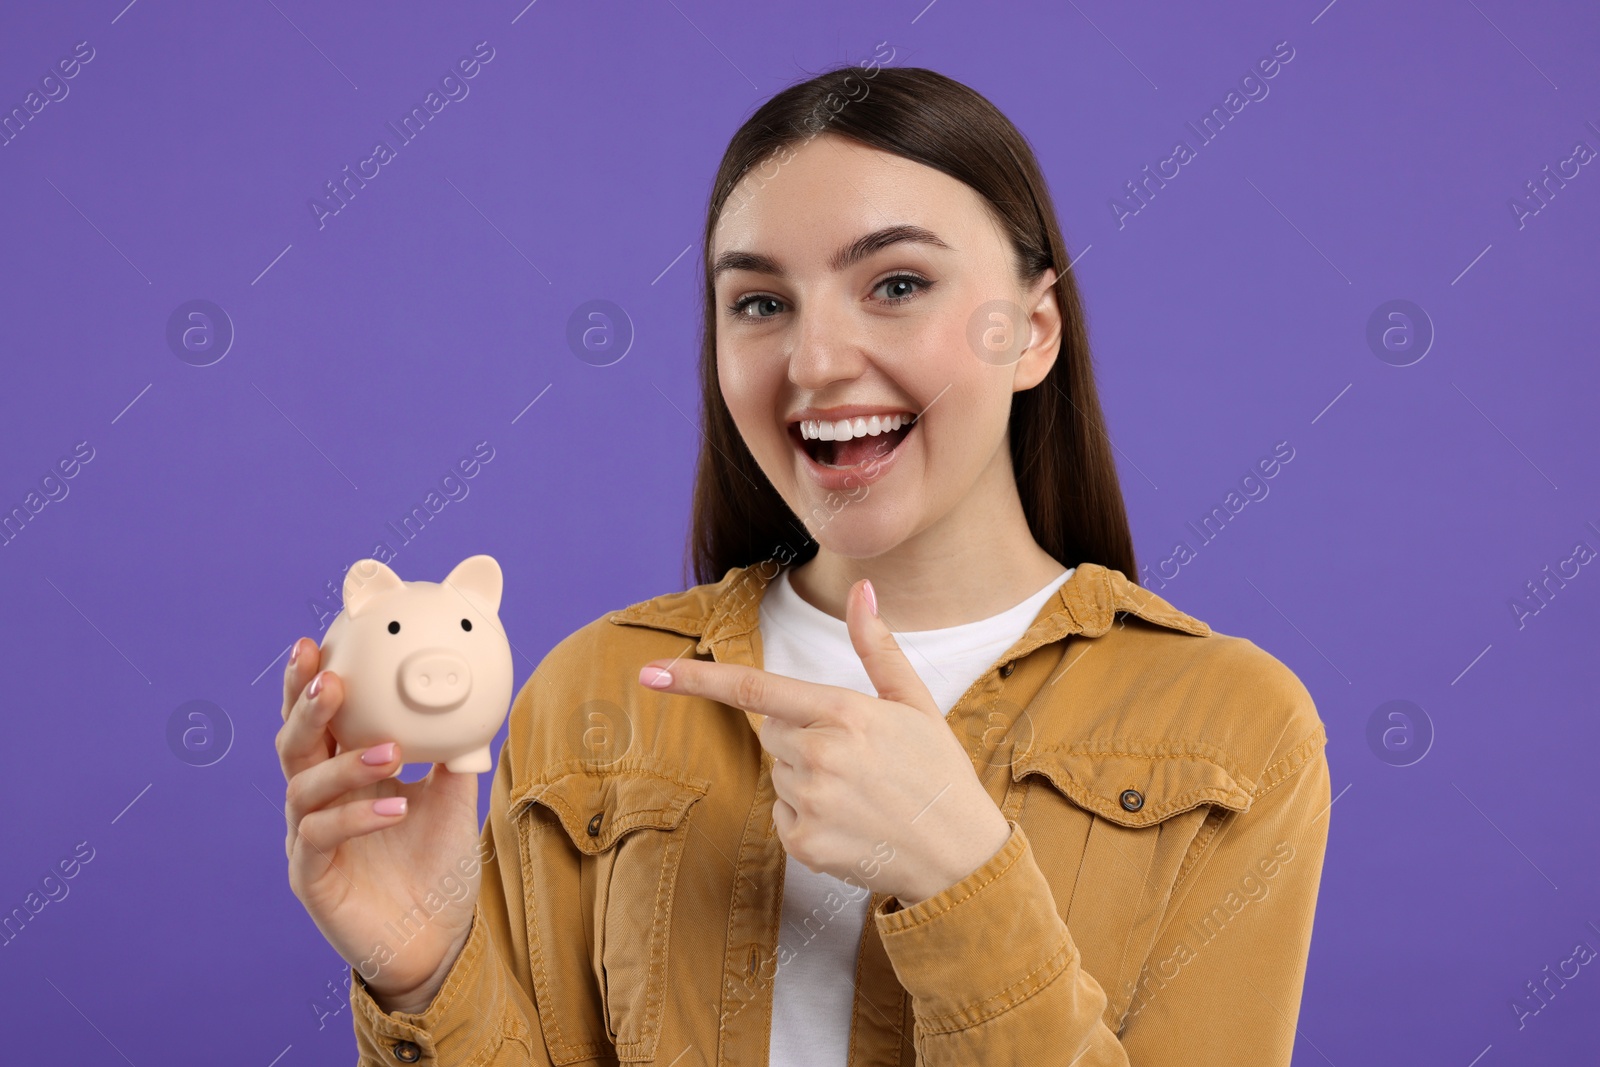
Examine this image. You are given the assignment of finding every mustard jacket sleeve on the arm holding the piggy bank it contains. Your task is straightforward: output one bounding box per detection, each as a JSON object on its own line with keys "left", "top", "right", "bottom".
{"left": 350, "top": 723, "right": 550, "bottom": 1067}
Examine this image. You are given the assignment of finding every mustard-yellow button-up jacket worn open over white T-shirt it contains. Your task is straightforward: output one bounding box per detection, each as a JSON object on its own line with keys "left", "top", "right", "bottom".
{"left": 350, "top": 561, "right": 1331, "bottom": 1067}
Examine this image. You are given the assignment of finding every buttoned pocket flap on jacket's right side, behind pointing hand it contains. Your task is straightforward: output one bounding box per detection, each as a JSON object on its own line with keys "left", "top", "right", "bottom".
{"left": 1011, "top": 744, "right": 1251, "bottom": 827}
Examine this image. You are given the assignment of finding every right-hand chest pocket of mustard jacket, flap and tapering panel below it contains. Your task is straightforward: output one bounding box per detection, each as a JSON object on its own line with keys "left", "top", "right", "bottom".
{"left": 1011, "top": 744, "right": 1250, "bottom": 1030}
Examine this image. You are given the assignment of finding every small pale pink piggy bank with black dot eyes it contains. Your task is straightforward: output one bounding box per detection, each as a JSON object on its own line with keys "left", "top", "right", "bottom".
{"left": 322, "top": 555, "right": 512, "bottom": 774}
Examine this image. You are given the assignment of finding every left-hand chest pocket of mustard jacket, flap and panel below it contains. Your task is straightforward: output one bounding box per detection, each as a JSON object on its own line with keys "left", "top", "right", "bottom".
{"left": 522, "top": 766, "right": 710, "bottom": 1064}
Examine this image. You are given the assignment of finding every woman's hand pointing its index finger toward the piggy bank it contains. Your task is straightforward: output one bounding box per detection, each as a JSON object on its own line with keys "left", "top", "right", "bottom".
{"left": 638, "top": 579, "right": 1011, "bottom": 907}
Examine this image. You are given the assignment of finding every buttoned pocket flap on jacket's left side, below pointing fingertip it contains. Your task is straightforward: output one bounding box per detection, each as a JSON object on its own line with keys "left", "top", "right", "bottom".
{"left": 510, "top": 766, "right": 710, "bottom": 856}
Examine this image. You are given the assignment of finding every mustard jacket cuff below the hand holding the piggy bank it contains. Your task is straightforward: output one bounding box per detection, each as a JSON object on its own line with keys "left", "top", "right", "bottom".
{"left": 350, "top": 904, "right": 506, "bottom": 1064}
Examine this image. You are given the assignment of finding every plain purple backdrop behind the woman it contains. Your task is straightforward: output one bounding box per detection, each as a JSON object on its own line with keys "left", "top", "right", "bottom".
{"left": 0, "top": 0, "right": 1600, "bottom": 1067}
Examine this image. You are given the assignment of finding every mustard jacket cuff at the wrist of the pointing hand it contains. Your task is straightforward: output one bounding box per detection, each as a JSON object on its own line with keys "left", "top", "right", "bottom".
{"left": 872, "top": 819, "right": 1077, "bottom": 1033}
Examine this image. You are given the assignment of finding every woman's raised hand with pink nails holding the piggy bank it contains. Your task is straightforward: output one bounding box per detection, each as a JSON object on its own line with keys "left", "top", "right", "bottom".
{"left": 277, "top": 638, "right": 482, "bottom": 1011}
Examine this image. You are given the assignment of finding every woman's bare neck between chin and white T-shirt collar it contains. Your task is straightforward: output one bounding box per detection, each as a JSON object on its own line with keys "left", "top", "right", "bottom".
{"left": 789, "top": 448, "right": 1066, "bottom": 630}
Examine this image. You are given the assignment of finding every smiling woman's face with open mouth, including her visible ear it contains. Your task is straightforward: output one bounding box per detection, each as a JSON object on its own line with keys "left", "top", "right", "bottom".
{"left": 712, "top": 134, "right": 1061, "bottom": 558}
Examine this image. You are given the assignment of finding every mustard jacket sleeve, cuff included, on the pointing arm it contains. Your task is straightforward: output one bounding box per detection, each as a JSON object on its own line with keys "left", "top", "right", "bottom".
{"left": 874, "top": 728, "right": 1330, "bottom": 1067}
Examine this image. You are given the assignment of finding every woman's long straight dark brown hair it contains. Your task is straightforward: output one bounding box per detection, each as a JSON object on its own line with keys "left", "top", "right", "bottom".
{"left": 685, "top": 67, "right": 1138, "bottom": 582}
